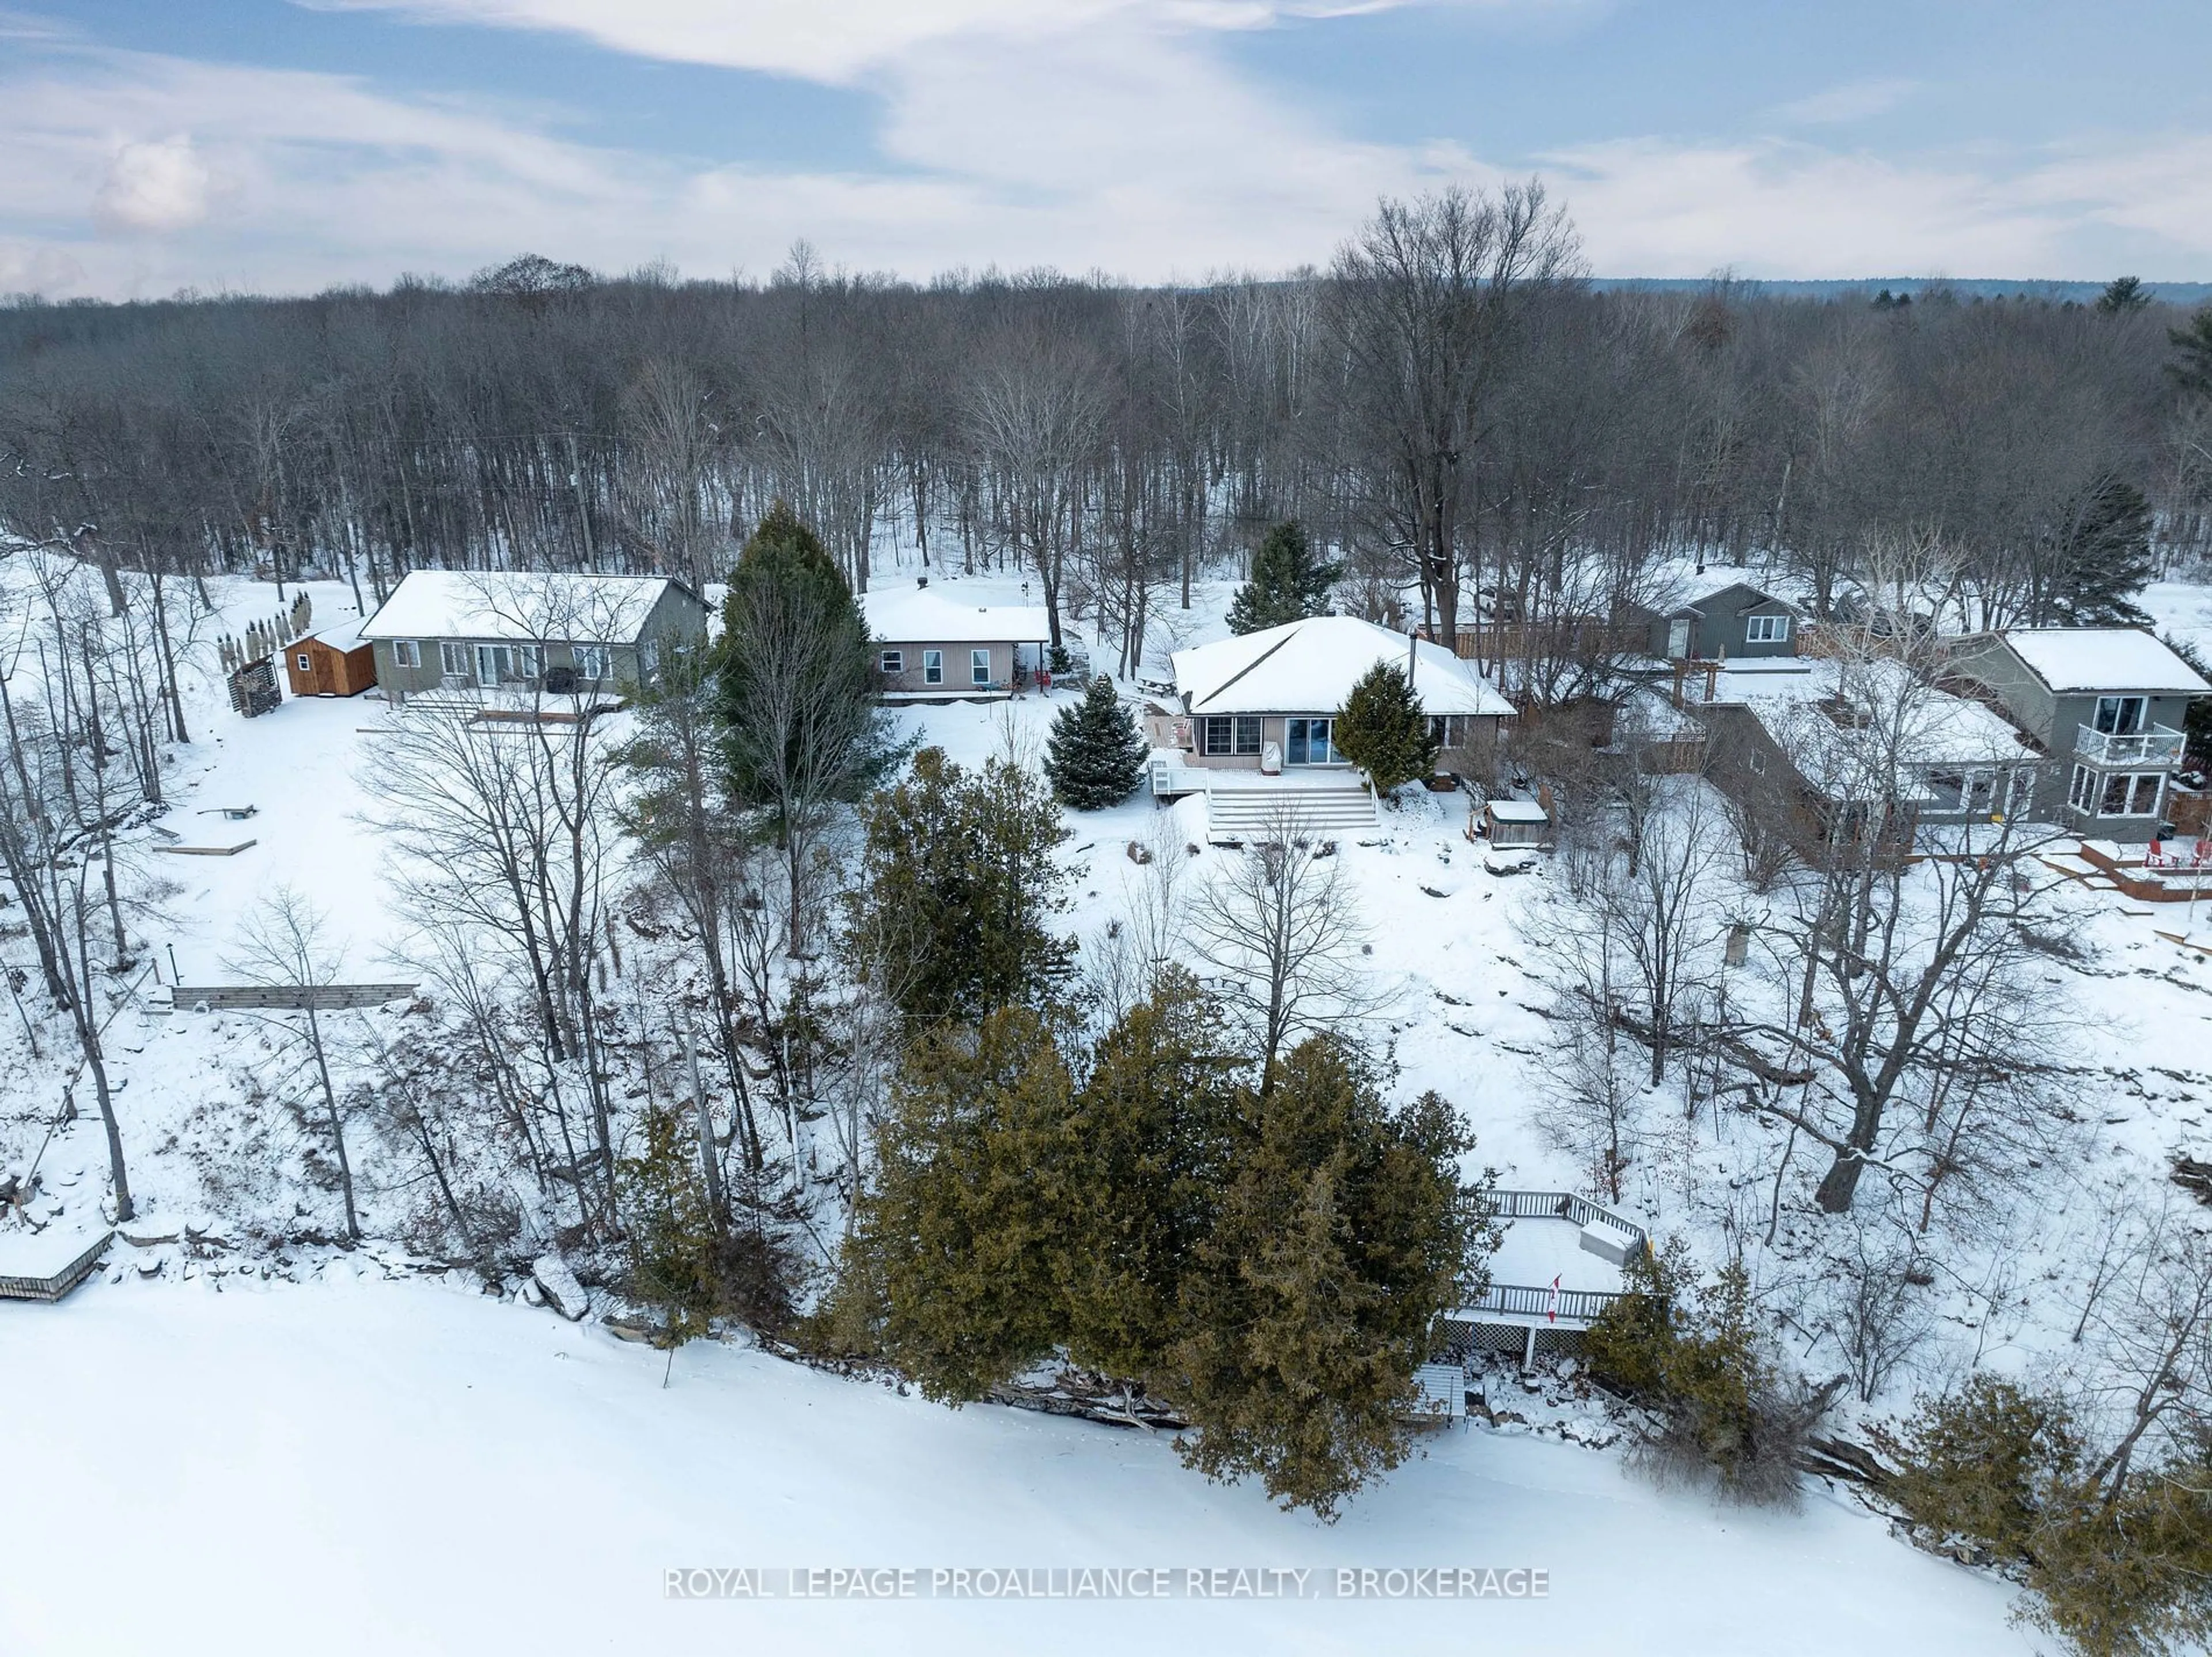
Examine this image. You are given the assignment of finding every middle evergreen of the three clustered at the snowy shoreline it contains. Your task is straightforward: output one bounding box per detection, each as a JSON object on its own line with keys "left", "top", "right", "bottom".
{"left": 1066, "top": 967, "right": 1243, "bottom": 1383}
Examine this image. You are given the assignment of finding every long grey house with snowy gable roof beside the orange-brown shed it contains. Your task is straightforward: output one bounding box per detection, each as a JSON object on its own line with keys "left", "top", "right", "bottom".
{"left": 361, "top": 569, "right": 708, "bottom": 701}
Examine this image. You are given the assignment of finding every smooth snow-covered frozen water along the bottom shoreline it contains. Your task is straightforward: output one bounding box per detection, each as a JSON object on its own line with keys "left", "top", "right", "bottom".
{"left": 0, "top": 1265, "right": 2028, "bottom": 1657}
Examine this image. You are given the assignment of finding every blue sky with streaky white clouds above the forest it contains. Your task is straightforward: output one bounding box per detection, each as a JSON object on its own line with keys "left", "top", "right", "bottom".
{"left": 0, "top": 0, "right": 2212, "bottom": 297}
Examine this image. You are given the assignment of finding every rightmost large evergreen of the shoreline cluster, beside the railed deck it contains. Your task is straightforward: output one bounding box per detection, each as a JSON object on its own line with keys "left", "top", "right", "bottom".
{"left": 1166, "top": 1035, "right": 1491, "bottom": 1520}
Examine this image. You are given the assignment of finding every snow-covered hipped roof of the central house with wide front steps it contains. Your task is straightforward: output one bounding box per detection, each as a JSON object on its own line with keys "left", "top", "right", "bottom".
{"left": 1175, "top": 615, "right": 1513, "bottom": 714}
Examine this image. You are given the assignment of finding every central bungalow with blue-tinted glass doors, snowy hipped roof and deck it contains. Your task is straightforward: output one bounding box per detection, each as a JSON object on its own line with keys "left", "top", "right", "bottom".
{"left": 1150, "top": 615, "right": 1513, "bottom": 841}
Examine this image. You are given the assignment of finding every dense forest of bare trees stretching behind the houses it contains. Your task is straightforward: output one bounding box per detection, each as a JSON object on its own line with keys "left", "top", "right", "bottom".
{"left": 0, "top": 199, "right": 2212, "bottom": 695}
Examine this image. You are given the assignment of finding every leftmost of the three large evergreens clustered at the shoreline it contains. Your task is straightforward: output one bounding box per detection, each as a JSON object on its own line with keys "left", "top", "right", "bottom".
{"left": 838, "top": 1007, "right": 1073, "bottom": 1402}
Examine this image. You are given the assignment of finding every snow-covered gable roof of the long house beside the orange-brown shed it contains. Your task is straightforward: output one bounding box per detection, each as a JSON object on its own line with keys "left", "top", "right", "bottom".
{"left": 361, "top": 569, "right": 677, "bottom": 644}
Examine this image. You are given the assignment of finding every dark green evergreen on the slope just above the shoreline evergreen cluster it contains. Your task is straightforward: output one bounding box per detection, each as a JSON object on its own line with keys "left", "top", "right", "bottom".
{"left": 845, "top": 748, "right": 1075, "bottom": 1029}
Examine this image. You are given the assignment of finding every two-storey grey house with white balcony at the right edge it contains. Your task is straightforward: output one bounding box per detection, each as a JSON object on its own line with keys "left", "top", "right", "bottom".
{"left": 1949, "top": 626, "right": 2212, "bottom": 845}
